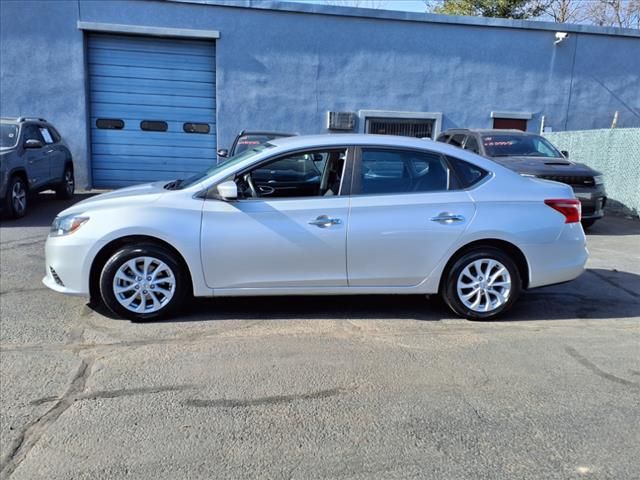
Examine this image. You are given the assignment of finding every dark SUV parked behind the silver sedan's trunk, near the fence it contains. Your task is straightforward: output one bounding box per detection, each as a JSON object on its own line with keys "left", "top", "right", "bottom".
{"left": 437, "top": 129, "right": 607, "bottom": 228}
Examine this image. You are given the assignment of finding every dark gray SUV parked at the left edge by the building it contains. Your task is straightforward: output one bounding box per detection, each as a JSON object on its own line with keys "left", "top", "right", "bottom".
{"left": 0, "top": 117, "right": 75, "bottom": 218}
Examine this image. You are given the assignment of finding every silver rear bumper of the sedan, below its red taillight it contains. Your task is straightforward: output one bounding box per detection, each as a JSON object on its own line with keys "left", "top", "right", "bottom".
{"left": 523, "top": 223, "right": 589, "bottom": 288}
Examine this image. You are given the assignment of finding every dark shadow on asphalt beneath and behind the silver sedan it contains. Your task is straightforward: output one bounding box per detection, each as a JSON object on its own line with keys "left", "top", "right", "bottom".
{"left": 91, "top": 269, "right": 640, "bottom": 323}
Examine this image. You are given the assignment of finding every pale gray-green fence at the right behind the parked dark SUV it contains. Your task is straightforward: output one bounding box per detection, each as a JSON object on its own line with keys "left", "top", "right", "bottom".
{"left": 544, "top": 128, "right": 640, "bottom": 216}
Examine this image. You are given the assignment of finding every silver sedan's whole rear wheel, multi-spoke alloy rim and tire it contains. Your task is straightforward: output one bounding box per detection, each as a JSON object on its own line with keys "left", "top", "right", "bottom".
{"left": 441, "top": 247, "right": 522, "bottom": 320}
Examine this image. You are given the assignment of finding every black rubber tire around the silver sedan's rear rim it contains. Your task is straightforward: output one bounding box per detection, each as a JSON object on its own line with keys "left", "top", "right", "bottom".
{"left": 440, "top": 247, "right": 522, "bottom": 320}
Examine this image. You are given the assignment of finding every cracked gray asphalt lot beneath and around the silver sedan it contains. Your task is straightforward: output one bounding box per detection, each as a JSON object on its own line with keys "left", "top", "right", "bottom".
{"left": 0, "top": 194, "right": 640, "bottom": 480}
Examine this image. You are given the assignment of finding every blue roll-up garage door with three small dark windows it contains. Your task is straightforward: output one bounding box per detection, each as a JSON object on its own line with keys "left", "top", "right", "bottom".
{"left": 88, "top": 34, "right": 216, "bottom": 188}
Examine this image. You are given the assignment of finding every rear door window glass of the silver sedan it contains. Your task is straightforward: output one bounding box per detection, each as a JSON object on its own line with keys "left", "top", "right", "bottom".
{"left": 354, "top": 148, "right": 450, "bottom": 195}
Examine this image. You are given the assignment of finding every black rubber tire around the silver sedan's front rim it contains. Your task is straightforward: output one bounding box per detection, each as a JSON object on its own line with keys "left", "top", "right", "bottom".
{"left": 100, "top": 243, "right": 189, "bottom": 322}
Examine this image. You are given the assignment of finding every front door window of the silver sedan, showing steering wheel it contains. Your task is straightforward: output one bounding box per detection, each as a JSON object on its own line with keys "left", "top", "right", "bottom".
{"left": 235, "top": 148, "right": 347, "bottom": 199}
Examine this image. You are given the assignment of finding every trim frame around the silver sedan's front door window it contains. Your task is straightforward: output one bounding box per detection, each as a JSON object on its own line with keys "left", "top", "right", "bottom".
{"left": 204, "top": 145, "right": 354, "bottom": 203}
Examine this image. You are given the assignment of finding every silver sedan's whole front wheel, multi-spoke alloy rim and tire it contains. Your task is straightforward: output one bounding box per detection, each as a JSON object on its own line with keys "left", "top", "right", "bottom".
{"left": 100, "top": 244, "right": 188, "bottom": 321}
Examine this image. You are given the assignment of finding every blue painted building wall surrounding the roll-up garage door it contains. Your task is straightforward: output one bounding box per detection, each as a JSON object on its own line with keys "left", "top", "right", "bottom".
{"left": 0, "top": 0, "right": 640, "bottom": 186}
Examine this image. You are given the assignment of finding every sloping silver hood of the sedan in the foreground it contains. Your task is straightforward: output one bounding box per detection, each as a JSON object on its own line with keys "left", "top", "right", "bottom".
{"left": 59, "top": 181, "right": 168, "bottom": 216}
